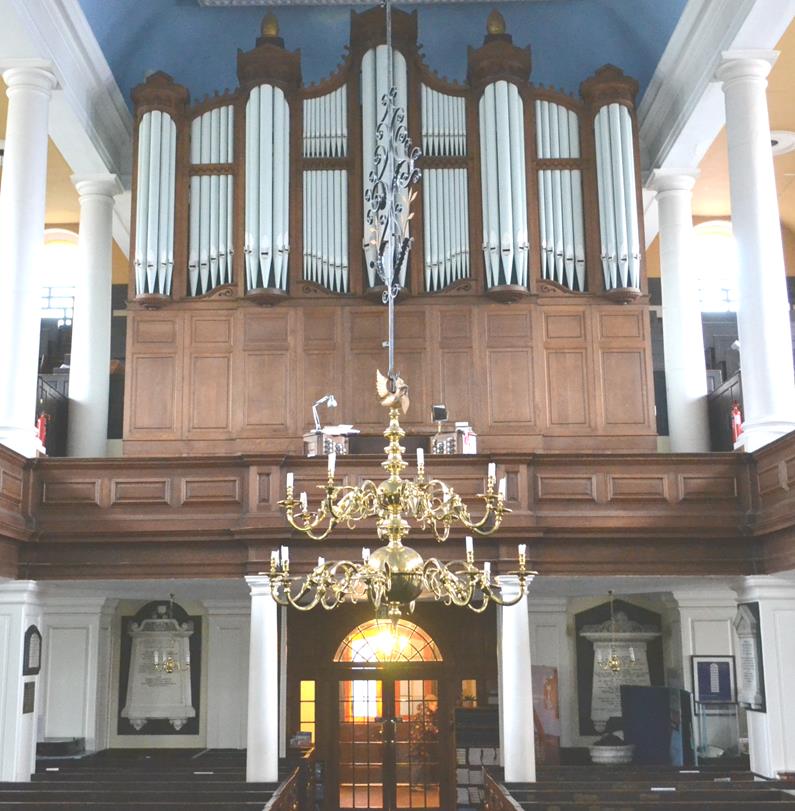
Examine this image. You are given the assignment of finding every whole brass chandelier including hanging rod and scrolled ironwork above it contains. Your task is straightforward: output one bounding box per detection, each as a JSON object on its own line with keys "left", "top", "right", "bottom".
{"left": 270, "top": 0, "right": 535, "bottom": 623}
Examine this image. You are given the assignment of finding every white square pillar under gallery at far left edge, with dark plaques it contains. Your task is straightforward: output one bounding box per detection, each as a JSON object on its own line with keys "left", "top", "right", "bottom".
{"left": 0, "top": 580, "right": 41, "bottom": 782}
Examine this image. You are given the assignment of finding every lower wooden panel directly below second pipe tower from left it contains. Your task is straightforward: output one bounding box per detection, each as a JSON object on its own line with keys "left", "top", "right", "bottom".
{"left": 243, "top": 352, "right": 293, "bottom": 432}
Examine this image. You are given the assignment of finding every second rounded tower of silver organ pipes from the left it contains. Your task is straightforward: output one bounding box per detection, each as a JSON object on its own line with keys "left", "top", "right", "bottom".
{"left": 244, "top": 84, "right": 290, "bottom": 291}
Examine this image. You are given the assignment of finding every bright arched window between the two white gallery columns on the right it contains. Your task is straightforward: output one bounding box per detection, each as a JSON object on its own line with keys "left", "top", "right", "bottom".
{"left": 693, "top": 220, "right": 739, "bottom": 313}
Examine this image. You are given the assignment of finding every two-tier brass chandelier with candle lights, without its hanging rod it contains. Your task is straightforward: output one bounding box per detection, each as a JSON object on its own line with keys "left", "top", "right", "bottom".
{"left": 270, "top": 384, "right": 536, "bottom": 622}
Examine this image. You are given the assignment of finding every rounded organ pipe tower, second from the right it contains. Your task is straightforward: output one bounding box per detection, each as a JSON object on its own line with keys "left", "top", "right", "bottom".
{"left": 479, "top": 80, "right": 529, "bottom": 287}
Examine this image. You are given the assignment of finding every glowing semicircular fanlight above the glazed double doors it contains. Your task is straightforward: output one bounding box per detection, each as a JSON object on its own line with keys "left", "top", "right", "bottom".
{"left": 334, "top": 620, "right": 442, "bottom": 664}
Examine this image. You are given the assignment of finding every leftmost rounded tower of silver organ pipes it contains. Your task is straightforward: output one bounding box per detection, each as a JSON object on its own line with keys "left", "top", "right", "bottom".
{"left": 133, "top": 110, "right": 177, "bottom": 296}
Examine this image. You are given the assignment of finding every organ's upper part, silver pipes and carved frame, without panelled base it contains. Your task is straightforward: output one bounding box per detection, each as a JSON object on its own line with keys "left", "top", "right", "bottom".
{"left": 126, "top": 10, "right": 645, "bottom": 306}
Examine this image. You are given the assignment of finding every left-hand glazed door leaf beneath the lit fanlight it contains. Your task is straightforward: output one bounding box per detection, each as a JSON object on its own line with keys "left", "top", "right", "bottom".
{"left": 337, "top": 679, "right": 384, "bottom": 809}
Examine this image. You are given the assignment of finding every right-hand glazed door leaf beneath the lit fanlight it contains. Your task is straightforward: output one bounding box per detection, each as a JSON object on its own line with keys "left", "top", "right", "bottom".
{"left": 395, "top": 679, "right": 442, "bottom": 809}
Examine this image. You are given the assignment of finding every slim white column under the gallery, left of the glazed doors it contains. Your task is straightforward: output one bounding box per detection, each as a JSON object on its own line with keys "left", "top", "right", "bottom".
{"left": 246, "top": 575, "right": 279, "bottom": 783}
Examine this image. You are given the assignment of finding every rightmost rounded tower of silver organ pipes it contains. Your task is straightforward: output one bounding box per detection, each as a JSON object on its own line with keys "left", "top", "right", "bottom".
{"left": 594, "top": 103, "right": 640, "bottom": 290}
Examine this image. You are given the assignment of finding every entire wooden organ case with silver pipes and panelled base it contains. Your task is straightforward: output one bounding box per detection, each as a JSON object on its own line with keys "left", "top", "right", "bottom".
{"left": 124, "top": 9, "right": 656, "bottom": 455}
